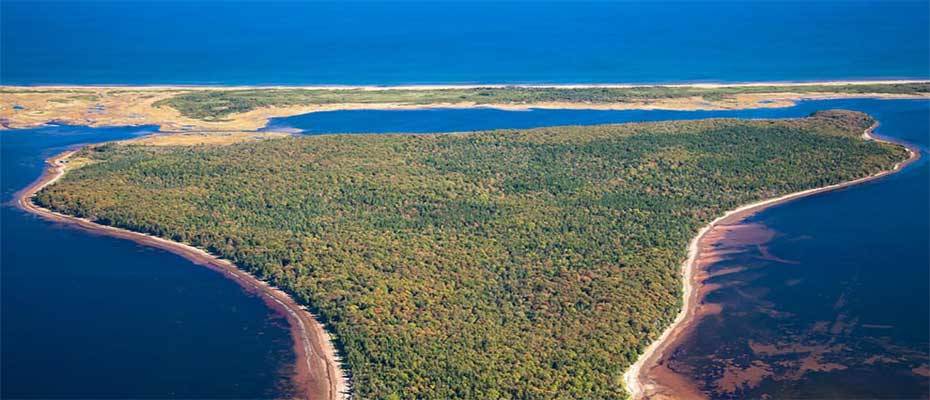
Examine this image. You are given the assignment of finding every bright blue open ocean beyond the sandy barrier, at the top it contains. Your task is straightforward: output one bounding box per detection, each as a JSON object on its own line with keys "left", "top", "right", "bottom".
{"left": 0, "top": 0, "right": 930, "bottom": 85}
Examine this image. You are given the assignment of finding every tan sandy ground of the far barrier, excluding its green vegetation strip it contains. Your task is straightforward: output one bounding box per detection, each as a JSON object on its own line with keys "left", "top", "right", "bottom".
{"left": 0, "top": 80, "right": 930, "bottom": 132}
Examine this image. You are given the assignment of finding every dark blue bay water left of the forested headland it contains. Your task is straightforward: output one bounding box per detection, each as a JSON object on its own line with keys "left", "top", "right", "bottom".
{"left": 0, "top": 126, "right": 294, "bottom": 399}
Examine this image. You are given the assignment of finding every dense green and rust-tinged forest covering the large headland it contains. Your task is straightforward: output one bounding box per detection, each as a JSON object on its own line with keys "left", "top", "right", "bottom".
{"left": 36, "top": 111, "right": 906, "bottom": 399}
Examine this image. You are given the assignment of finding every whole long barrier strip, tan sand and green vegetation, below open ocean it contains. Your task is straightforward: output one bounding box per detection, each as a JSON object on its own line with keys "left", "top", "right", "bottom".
{"left": 0, "top": 81, "right": 930, "bottom": 133}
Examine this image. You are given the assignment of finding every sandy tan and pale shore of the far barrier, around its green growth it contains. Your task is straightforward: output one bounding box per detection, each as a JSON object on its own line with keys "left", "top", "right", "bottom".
{"left": 0, "top": 80, "right": 930, "bottom": 132}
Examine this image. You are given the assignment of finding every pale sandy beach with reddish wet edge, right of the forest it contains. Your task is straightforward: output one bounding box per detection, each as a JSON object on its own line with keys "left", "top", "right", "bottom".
{"left": 623, "top": 123, "right": 920, "bottom": 400}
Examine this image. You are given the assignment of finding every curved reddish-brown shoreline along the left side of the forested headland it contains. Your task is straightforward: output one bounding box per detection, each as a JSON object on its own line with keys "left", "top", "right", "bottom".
{"left": 15, "top": 150, "right": 349, "bottom": 400}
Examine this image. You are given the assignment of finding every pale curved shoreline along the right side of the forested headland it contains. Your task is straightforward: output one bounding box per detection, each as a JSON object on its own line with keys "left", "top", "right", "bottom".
{"left": 623, "top": 122, "right": 920, "bottom": 400}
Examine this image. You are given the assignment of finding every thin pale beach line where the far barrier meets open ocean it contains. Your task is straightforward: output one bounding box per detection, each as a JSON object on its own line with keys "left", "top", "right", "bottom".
{"left": 0, "top": 78, "right": 930, "bottom": 90}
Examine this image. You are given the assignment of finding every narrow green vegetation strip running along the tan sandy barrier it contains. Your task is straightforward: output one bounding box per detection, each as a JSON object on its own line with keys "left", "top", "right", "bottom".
{"left": 155, "top": 82, "right": 930, "bottom": 121}
